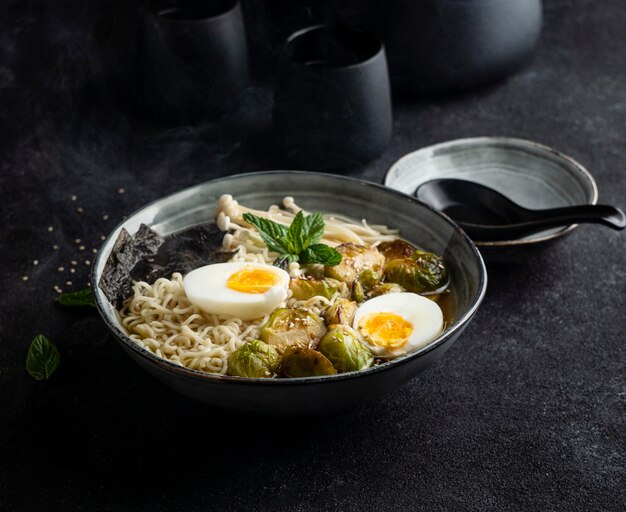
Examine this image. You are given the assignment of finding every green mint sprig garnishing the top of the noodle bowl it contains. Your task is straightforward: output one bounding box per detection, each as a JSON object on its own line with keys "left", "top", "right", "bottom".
{"left": 243, "top": 212, "right": 341, "bottom": 268}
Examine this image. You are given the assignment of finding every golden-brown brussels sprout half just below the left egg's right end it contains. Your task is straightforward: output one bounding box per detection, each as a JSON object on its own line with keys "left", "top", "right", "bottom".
{"left": 261, "top": 308, "right": 326, "bottom": 353}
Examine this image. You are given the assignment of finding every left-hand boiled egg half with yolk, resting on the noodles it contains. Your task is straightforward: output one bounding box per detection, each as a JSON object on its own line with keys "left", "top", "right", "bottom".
{"left": 183, "top": 262, "right": 289, "bottom": 320}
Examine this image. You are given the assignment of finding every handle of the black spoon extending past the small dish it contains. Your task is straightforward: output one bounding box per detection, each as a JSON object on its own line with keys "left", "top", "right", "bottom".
{"left": 528, "top": 204, "right": 626, "bottom": 230}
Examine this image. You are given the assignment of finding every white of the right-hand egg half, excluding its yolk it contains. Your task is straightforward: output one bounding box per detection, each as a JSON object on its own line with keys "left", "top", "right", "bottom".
{"left": 352, "top": 292, "right": 443, "bottom": 358}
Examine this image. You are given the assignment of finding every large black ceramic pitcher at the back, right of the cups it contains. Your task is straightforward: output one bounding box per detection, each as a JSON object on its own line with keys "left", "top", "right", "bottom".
{"left": 332, "top": 0, "right": 542, "bottom": 94}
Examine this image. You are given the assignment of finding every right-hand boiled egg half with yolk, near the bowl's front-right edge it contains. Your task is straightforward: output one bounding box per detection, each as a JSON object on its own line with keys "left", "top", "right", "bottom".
{"left": 353, "top": 292, "right": 443, "bottom": 358}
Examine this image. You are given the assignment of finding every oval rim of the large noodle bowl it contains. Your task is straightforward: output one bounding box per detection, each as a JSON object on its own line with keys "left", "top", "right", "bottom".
{"left": 90, "top": 170, "right": 487, "bottom": 386}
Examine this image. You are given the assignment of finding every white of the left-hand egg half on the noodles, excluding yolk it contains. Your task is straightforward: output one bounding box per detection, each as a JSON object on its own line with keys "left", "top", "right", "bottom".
{"left": 183, "top": 262, "right": 289, "bottom": 320}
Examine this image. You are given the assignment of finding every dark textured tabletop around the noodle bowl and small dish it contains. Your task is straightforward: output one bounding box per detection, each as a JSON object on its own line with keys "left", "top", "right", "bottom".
{"left": 0, "top": 0, "right": 626, "bottom": 511}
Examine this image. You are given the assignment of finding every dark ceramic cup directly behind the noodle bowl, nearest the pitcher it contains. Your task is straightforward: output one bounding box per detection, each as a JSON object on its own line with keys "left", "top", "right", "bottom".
{"left": 273, "top": 25, "right": 392, "bottom": 170}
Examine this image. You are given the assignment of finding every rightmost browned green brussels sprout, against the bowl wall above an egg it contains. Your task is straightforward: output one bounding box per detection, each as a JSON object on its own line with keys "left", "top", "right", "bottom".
{"left": 385, "top": 251, "right": 448, "bottom": 293}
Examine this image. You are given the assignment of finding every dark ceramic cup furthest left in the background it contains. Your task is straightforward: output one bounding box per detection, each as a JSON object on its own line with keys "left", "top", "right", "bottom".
{"left": 140, "top": 0, "right": 248, "bottom": 122}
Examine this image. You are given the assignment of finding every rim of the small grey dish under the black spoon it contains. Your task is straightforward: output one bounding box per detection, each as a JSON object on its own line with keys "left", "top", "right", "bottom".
{"left": 381, "top": 135, "right": 598, "bottom": 247}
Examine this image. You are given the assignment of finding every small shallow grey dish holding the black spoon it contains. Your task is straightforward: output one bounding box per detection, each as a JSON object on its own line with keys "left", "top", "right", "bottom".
{"left": 383, "top": 137, "right": 598, "bottom": 256}
